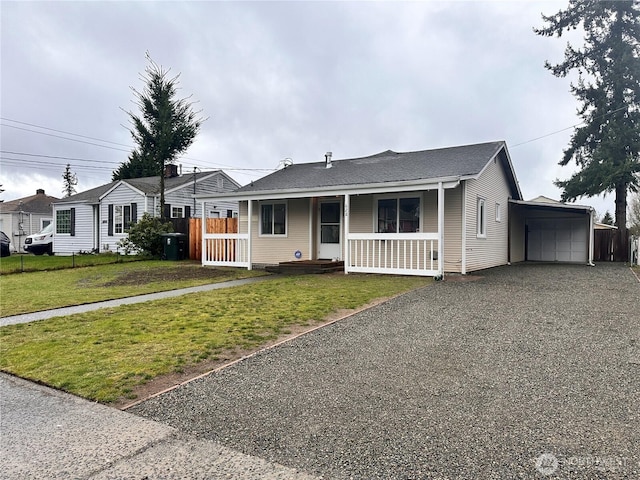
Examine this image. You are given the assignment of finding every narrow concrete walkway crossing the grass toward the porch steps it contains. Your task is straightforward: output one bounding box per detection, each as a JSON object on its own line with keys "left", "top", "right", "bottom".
{"left": 0, "top": 276, "right": 274, "bottom": 327}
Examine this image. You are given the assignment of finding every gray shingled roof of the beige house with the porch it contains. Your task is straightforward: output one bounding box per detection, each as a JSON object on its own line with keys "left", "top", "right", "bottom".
{"left": 237, "top": 142, "right": 515, "bottom": 193}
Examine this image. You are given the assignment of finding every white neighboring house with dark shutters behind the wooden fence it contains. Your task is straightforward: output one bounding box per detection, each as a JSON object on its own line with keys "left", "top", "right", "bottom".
{"left": 53, "top": 165, "right": 239, "bottom": 254}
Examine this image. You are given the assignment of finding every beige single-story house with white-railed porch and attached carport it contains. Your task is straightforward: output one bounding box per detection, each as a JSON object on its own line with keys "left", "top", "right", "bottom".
{"left": 197, "top": 141, "right": 593, "bottom": 276}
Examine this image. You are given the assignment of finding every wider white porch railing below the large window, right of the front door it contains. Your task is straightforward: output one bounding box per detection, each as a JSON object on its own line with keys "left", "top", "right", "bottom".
{"left": 345, "top": 233, "right": 440, "bottom": 276}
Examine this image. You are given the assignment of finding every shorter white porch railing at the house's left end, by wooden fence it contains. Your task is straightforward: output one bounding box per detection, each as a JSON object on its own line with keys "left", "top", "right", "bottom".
{"left": 202, "top": 233, "right": 249, "bottom": 268}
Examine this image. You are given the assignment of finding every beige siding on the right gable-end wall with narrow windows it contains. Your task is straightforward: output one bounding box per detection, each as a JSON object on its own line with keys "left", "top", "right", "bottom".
{"left": 465, "top": 158, "right": 510, "bottom": 272}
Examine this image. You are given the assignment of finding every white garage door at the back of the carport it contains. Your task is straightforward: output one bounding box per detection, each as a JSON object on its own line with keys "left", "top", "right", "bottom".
{"left": 527, "top": 218, "right": 588, "bottom": 263}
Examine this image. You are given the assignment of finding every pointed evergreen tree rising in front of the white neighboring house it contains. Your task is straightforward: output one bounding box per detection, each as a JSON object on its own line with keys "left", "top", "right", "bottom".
{"left": 112, "top": 52, "right": 204, "bottom": 218}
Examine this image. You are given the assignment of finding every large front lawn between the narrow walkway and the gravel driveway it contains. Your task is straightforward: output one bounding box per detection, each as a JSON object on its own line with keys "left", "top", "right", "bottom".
{"left": 0, "top": 274, "right": 431, "bottom": 403}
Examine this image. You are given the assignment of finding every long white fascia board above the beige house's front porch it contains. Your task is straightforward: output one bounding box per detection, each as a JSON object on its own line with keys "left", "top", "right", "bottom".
{"left": 196, "top": 177, "right": 460, "bottom": 201}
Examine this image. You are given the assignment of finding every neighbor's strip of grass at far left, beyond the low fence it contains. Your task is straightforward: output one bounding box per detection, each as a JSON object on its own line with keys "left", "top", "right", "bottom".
{"left": 0, "top": 253, "right": 146, "bottom": 275}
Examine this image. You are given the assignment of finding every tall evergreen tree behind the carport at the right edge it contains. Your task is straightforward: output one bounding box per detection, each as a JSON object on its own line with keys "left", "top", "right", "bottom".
{"left": 535, "top": 0, "right": 640, "bottom": 260}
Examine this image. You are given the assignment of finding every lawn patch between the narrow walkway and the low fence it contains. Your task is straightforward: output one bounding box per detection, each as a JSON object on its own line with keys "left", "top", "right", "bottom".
{"left": 0, "top": 257, "right": 264, "bottom": 317}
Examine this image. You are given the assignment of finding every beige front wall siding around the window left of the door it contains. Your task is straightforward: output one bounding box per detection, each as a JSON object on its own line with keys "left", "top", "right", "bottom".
{"left": 249, "top": 198, "right": 311, "bottom": 264}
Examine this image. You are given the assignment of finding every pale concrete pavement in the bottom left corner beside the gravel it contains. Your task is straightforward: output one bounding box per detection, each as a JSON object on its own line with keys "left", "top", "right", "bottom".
{"left": 0, "top": 373, "right": 313, "bottom": 480}
